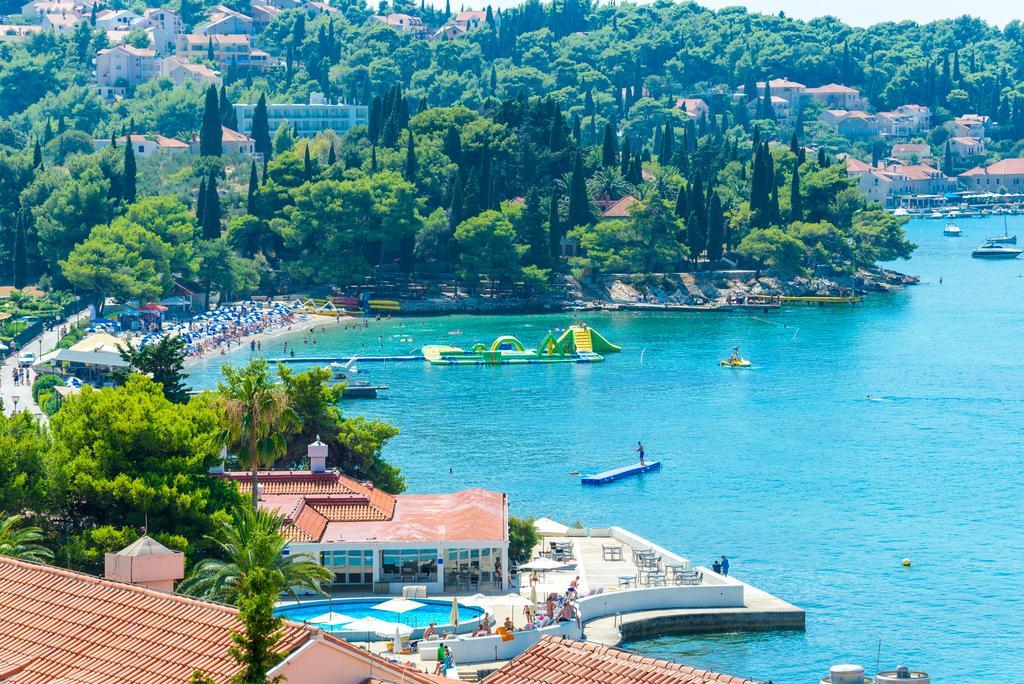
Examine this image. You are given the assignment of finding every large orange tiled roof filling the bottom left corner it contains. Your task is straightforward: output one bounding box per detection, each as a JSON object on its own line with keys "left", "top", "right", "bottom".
{"left": 0, "top": 557, "right": 310, "bottom": 684}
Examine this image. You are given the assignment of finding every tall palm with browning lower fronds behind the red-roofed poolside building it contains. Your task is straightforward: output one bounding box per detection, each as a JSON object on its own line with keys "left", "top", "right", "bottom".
{"left": 216, "top": 357, "right": 301, "bottom": 510}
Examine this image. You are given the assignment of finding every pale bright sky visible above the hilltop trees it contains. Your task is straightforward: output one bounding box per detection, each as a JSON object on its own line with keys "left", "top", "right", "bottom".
{"left": 471, "top": 0, "right": 1024, "bottom": 27}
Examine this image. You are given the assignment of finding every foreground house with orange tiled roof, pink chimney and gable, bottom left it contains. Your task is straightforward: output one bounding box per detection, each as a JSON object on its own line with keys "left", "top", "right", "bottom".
{"left": 0, "top": 557, "right": 451, "bottom": 684}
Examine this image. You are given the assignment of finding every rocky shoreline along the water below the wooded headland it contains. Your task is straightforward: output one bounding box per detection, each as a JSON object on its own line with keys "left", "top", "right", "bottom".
{"left": 393, "top": 267, "right": 919, "bottom": 315}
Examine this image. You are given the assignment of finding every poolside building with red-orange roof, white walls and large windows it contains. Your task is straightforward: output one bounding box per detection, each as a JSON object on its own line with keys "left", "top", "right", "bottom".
{"left": 214, "top": 440, "right": 509, "bottom": 595}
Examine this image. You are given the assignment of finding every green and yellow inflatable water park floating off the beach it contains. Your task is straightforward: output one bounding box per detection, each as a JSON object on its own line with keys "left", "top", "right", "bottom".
{"left": 423, "top": 324, "right": 622, "bottom": 366}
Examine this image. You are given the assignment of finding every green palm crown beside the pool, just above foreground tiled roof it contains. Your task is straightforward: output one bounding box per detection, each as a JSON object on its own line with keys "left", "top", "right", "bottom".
{"left": 179, "top": 506, "right": 331, "bottom": 603}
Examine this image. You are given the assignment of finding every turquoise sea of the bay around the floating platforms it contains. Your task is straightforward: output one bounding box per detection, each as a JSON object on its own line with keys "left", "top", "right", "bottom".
{"left": 193, "top": 217, "right": 1024, "bottom": 684}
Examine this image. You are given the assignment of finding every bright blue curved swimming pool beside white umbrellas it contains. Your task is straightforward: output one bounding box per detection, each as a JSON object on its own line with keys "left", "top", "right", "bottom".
{"left": 274, "top": 597, "right": 483, "bottom": 640}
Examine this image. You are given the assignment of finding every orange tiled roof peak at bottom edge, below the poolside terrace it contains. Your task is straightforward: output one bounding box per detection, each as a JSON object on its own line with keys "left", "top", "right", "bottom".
{"left": 483, "top": 637, "right": 754, "bottom": 684}
